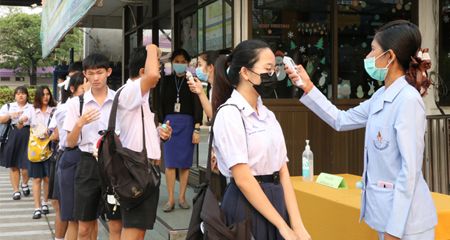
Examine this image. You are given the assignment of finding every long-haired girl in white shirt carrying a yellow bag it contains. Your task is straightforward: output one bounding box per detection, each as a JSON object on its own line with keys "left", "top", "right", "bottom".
{"left": 19, "top": 86, "right": 56, "bottom": 219}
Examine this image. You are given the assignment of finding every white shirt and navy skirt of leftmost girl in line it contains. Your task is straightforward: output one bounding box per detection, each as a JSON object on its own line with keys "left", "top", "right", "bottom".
{"left": 0, "top": 102, "right": 33, "bottom": 169}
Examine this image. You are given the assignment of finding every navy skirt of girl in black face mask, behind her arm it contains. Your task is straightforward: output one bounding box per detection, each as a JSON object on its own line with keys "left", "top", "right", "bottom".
{"left": 221, "top": 182, "right": 289, "bottom": 240}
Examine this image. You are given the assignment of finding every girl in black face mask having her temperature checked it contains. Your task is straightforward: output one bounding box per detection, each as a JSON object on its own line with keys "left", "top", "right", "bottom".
{"left": 212, "top": 40, "right": 311, "bottom": 240}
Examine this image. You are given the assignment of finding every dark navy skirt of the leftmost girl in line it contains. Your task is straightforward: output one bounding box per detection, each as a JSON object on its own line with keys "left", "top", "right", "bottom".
{"left": 1, "top": 126, "right": 30, "bottom": 169}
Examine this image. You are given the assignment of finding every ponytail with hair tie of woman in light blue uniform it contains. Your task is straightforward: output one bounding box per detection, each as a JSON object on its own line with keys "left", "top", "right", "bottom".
{"left": 406, "top": 48, "right": 431, "bottom": 97}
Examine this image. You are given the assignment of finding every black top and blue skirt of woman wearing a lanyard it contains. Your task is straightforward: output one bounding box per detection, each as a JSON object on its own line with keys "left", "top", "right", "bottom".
{"left": 158, "top": 75, "right": 203, "bottom": 169}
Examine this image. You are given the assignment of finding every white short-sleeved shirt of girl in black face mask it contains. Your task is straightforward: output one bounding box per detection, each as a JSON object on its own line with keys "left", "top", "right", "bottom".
{"left": 213, "top": 90, "right": 288, "bottom": 177}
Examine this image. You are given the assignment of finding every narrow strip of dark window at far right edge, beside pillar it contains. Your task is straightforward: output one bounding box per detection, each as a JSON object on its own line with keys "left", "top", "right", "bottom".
{"left": 440, "top": 0, "right": 450, "bottom": 106}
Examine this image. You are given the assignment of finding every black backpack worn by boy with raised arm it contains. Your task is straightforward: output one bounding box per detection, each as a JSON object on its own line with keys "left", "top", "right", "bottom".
{"left": 98, "top": 89, "right": 161, "bottom": 209}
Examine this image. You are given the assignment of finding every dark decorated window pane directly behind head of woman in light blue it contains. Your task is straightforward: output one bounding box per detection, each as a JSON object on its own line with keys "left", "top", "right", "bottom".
{"left": 336, "top": 0, "right": 414, "bottom": 99}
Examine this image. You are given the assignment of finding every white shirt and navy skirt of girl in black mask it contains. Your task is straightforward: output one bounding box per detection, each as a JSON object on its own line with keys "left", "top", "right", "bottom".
{"left": 213, "top": 90, "right": 289, "bottom": 240}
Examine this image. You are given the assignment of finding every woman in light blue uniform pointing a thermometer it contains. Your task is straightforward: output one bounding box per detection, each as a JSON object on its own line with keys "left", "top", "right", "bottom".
{"left": 288, "top": 20, "right": 437, "bottom": 240}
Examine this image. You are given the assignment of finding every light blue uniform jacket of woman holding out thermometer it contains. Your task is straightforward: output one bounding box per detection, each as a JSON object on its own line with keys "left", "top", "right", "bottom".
{"left": 300, "top": 76, "right": 437, "bottom": 240}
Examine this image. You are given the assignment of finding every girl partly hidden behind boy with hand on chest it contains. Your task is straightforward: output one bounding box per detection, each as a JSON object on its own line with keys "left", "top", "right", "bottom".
{"left": 49, "top": 71, "right": 89, "bottom": 240}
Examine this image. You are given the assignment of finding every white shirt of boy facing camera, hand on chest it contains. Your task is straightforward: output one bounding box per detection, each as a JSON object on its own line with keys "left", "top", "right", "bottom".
{"left": 63, "top": 88, "right": 116, "bottom": 153}
